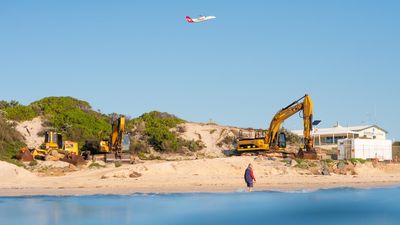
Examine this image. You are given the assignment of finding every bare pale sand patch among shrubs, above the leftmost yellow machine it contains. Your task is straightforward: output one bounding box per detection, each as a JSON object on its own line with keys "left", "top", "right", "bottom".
{"left": 15, "top": 117, "right": 44, "bottom": 148}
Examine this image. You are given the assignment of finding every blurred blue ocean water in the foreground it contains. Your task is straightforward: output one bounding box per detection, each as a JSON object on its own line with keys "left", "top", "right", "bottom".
{"left": 0, "top": 188, "right": 400, "bottom": 225}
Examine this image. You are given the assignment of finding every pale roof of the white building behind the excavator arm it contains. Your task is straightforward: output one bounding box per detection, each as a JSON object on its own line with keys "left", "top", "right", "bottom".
{"left": 292, "top": 125, "right": 387, "bottom": 136}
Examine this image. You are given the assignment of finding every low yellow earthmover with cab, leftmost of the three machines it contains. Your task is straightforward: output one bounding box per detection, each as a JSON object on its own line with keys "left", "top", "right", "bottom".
{"left": 17, "top": 131, "right": 85, "bottom": 165}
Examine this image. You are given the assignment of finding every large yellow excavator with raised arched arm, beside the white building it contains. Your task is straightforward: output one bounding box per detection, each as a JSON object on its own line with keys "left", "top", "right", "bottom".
{"left": 237, "top": 94, "right": 317, "bottom": 159}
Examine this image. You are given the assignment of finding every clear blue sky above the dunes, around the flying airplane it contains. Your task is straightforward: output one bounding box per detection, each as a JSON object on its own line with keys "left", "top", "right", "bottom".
{"left": 0, "top": 0, "right": 400, "bottom": 140}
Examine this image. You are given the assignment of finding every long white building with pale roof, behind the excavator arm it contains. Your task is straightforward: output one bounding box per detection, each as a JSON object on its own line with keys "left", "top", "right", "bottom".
{"left": 292, "top": 124, "right": 387, "bottom": 148}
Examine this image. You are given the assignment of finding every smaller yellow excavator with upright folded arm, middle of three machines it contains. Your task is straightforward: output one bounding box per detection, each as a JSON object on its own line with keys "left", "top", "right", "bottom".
{"left": 85, "top": 115, "right": 132, "bottom": 162}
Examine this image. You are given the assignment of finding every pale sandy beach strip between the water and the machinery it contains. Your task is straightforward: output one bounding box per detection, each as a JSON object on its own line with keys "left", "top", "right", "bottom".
{"left": 0, "top": 156, "right": 400, "bottom": 196}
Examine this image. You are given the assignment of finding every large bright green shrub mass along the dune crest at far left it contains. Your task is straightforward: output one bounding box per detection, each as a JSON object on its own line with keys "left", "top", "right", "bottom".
{"left": 0, "top": 97, "right": 111, "bottom": 146}
